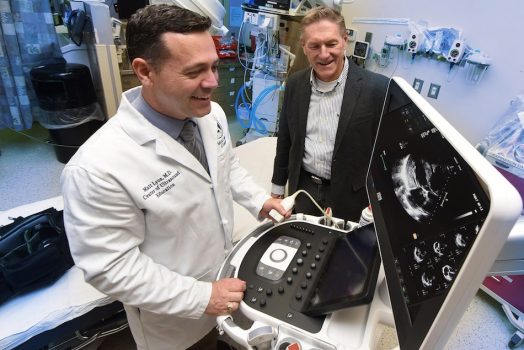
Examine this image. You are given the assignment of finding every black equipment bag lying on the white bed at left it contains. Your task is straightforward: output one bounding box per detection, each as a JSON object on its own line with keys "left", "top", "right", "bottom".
{"left": 0, "top": 208, "right": 74, "bottom": 303}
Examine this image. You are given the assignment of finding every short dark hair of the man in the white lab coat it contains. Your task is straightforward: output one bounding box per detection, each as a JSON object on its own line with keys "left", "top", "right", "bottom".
{"left": 126, "top": 4, "right": 211, "bottom": 67}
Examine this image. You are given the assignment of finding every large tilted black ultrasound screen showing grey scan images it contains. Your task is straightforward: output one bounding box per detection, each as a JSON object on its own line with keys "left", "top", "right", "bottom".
{"left": 368, "top": 80, "right": 490, "bottom": 348}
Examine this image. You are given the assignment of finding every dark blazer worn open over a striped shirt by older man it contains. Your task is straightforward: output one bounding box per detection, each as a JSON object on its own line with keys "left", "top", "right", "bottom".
{"left": 271, "top": 59, "right": 389, "bottom": 221}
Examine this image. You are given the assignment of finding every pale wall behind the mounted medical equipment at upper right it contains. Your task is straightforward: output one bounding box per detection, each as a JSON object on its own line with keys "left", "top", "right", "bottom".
{"left": 342, "top": 0, "right": 524, "bottom": 144}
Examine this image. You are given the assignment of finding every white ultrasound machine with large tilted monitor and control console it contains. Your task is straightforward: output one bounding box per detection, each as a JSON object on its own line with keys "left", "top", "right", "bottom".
{"left": 217, "top": 77, "right": 522, "bottom": 350}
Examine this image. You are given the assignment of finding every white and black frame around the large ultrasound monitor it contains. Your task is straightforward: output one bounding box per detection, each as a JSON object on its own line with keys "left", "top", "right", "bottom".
{"left": 366, "top": 77, "right": 522, "bottom": 349}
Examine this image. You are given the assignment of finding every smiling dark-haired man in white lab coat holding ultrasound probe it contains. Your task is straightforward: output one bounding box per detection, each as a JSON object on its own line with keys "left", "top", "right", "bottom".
{"left": 61, "top": 5, "right": 290, "bottom": 350}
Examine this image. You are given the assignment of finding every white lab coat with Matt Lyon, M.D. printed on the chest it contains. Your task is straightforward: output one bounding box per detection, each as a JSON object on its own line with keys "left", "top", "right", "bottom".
{"left": 61, "top": 87, "right": 269, "bottom": 350}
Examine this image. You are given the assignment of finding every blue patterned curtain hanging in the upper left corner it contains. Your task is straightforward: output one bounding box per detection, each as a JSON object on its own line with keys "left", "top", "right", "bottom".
{"left": 0, "top": 0, "right": 65, "bottom": 130}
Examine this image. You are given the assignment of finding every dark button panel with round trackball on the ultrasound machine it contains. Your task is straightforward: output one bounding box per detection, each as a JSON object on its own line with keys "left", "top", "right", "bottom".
{"left": 238, "top": 221, "right": 341, "bottom": 333}
